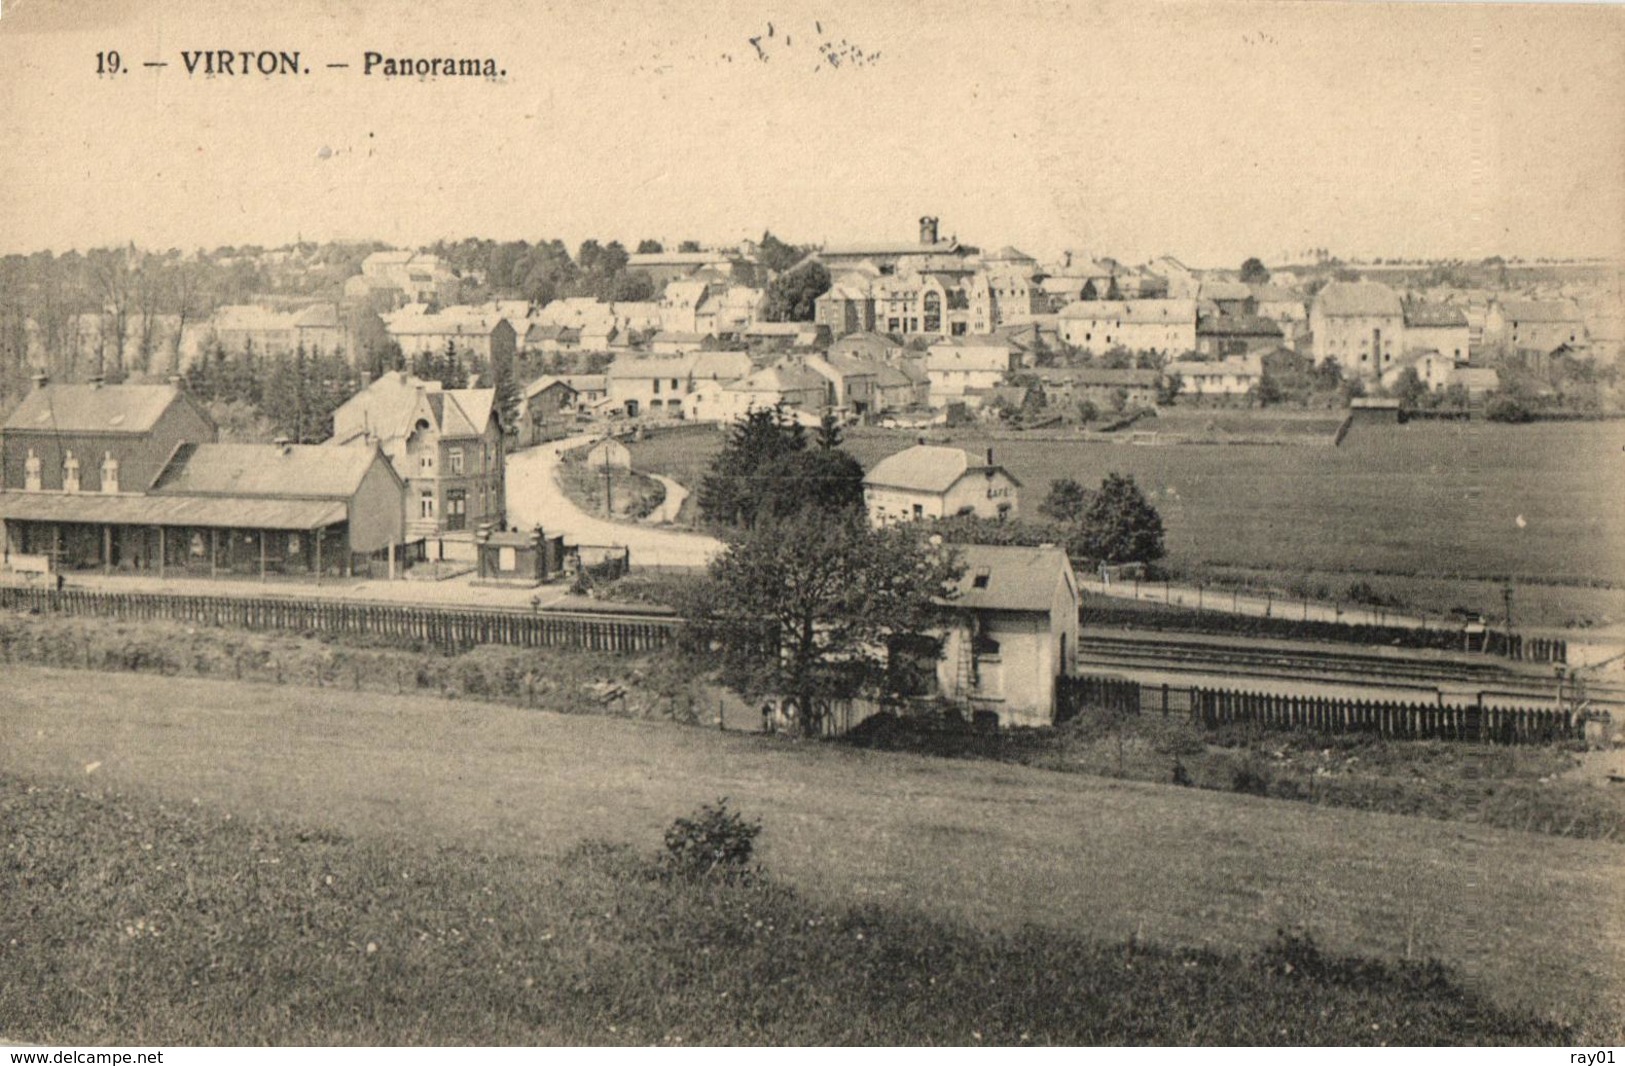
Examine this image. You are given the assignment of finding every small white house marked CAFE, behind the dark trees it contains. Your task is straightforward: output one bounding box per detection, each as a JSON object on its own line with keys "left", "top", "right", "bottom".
{"left": 863, "top": 444, "right": 1021, "bottom": 527}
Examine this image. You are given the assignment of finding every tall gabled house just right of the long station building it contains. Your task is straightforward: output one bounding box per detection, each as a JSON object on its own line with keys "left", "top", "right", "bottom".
{"left": 327, "top": 371, "right": 507, "bottom": 538}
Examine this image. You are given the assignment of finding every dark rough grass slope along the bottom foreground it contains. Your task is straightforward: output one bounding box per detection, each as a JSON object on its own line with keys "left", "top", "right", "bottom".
{"left": 0, "top": 775, "right": 1589, "bottom": 1045}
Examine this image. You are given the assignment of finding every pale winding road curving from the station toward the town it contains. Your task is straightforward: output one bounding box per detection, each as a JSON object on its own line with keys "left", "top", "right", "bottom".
{"left": 507, "top": 434, "right": 723, "bottom": 569}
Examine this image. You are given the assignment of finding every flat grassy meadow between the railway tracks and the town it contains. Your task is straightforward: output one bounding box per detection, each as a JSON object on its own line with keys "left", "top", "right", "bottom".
{"left": 634, "top": 423, "right": 1625, "bottom": 626}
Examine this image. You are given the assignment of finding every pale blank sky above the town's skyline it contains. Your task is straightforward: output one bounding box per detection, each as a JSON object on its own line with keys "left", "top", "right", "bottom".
{"left": 0, "top": 0, "right": 1625, "bottom": 267}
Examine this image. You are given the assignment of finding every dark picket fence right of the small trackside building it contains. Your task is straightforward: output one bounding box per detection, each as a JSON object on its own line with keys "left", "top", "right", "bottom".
{"left": 1056, "top": 676, "right": 1586, "bottom": 744}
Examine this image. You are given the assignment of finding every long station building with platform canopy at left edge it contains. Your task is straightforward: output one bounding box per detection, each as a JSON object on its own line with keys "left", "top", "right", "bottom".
{"left": 0, "top": 382, "right": 405, "bottom": 582}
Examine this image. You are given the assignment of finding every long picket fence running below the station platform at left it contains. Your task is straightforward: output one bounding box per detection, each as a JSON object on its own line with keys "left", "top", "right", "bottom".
{"left": 0, "top": 587, "right": 679, "bottom": 653}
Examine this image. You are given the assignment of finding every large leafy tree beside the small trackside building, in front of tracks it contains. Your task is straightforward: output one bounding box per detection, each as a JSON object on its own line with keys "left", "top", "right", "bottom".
{"left": 687, "top": 509, "right": 964, "bottom": 733}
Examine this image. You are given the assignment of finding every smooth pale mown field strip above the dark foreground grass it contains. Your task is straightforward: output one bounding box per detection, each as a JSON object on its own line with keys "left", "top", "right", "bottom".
{"left": 0, "top": 666, "right": 1625, "bottom": 1030}
